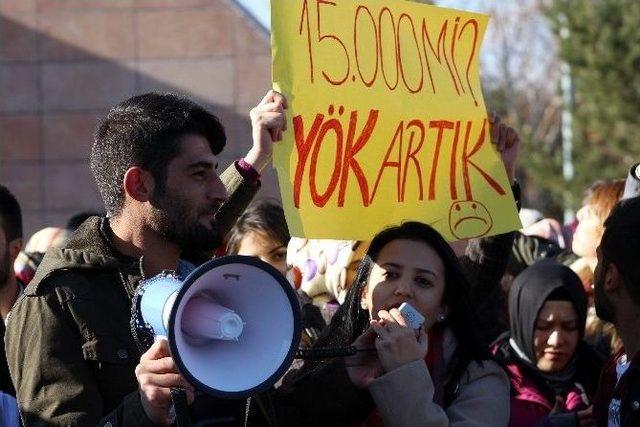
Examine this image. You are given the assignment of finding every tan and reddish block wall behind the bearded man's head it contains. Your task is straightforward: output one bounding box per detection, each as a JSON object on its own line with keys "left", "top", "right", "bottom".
{"left": 0, "top": 0, "right": 278, "bottom": 236}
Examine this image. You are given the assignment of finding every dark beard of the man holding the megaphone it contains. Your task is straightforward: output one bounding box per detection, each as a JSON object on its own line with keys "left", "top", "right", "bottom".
{"left": 152, "top": 194, "right": 224, "bottom": 252}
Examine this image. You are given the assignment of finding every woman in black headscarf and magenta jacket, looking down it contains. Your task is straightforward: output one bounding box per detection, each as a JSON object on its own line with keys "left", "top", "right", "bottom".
{"left": 492, "top": 259, "right": 604, "bottom": 427}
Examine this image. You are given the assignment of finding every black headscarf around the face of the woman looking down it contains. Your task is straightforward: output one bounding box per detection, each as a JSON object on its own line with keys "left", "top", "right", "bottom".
{"left": 509, "top": 259, "right": 587, "bottom": 390}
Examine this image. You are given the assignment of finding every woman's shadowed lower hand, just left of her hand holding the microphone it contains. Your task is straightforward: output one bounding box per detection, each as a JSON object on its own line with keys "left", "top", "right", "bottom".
{"left": 344, "top": 328, "right": 384, "bottom": 388}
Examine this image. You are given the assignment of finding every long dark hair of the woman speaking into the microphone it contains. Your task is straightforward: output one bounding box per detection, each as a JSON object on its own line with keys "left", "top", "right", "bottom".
{"left": 300, "top": 221, "right": 490, "bottom": 398}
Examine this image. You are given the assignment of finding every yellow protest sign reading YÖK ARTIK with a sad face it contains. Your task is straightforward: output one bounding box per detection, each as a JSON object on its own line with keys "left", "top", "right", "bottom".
{"left": 271, "top": 0, "right": 520, "bottom": 240}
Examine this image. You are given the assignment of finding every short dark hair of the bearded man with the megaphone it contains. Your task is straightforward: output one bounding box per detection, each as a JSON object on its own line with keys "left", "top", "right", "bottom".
{"left": 91, "top": 93, "right": 227, "bottom": 216}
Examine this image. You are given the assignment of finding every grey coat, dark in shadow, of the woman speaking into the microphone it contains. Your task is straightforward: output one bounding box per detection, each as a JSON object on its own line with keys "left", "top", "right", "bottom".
{"left": 273, "top": 330, "right": 509, "bottom": 427}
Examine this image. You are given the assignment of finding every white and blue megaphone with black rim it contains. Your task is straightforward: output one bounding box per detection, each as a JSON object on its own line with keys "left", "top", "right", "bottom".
{"left": 132, "top": 255, "right": 301, "bottom": 398}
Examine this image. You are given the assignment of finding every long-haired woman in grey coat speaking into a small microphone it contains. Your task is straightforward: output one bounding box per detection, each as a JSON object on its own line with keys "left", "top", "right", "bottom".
{"left": 262, "top": 222, "right": 509, "bottom": 427}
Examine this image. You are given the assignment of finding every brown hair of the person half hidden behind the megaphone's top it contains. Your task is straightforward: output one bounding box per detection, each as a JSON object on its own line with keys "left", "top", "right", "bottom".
{"left": 227, "top": 199, "right": 291, "bottom": 254}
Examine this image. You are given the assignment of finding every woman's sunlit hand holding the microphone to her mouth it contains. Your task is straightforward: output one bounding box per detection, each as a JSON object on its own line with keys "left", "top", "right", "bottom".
{"left": 371, "top": 308, "right": 429, "bottom": 372}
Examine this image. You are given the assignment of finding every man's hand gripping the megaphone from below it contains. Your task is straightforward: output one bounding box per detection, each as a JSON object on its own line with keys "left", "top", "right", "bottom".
{"left": 135, "top": 339, "right": 194, "bottom": 426}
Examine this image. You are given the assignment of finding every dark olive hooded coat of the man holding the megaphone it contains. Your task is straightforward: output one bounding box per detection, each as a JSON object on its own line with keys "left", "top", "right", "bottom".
{"left": 5, "top": 165, "right": 258, "bottom": 426}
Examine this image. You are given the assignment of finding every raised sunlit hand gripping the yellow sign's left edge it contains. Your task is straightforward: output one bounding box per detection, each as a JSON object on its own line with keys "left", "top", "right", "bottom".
{"left": 244, "top": 90, "right": 287, "bottom": 172}
